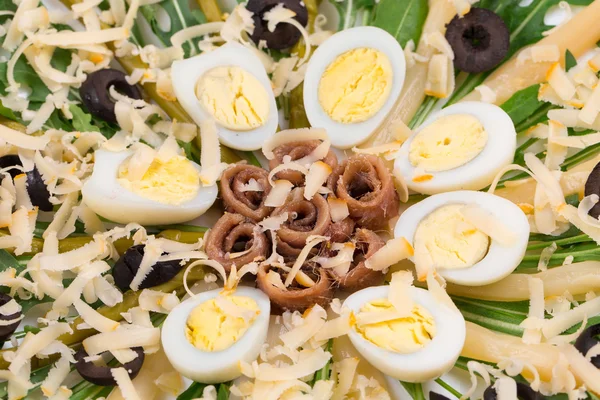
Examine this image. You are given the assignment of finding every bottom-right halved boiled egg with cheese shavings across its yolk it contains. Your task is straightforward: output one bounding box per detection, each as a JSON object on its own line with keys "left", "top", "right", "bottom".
{"left": 344, "top": 286, "right": 466, "bottom": 382}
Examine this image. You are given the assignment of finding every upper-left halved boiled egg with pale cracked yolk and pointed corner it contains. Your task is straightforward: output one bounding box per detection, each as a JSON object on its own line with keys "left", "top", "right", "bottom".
{"left": 171, "top": 42, "right": 279, "bottom": 150}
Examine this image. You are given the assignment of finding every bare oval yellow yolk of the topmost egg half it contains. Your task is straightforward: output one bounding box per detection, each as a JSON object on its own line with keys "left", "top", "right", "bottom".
{"left": 318, "top": 48, "right": 393, "bottom": 124}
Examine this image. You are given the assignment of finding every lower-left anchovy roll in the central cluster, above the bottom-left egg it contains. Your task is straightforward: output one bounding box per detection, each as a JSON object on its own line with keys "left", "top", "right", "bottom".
{"left": 205, "top": 213, "right": 270, "bottom": 272}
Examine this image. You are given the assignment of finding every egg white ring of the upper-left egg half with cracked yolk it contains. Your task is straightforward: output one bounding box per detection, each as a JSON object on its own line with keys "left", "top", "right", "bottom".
{"left": 171, "top": 43, "right": 279, "bottom": 150}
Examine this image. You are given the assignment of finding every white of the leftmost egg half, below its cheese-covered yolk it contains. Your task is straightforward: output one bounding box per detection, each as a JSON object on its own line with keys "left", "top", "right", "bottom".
{"left": 81, "top": 150, "right": 218, "bottom": 225}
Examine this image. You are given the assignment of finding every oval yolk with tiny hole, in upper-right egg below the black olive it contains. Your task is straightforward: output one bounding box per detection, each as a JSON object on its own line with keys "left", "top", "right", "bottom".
{"left": 408, "top": 114, "right": 488, "bottom": 172}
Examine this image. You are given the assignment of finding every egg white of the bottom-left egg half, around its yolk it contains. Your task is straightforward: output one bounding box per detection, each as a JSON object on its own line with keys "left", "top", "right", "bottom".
{"left": 161, "top": 287, "right": 271, "bottom": 383}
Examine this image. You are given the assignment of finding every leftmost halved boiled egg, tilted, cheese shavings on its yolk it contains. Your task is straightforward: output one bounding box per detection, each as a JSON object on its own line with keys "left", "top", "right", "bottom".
{"left": 81, "top": 150, "right": 218, "bottom": 225}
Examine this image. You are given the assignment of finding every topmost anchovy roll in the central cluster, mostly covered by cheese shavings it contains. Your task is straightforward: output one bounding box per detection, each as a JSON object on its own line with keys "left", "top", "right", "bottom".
{"left": 269, "top": 140, "right": 338, "bottom": 186}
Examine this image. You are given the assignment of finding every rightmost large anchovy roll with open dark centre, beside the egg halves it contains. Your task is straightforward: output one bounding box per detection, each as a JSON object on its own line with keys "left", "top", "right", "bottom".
{"left": 329, "top": 154, "right": 400, "bottom": 229}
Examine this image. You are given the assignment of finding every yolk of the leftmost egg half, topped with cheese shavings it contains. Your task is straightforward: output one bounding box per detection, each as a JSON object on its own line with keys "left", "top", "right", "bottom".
{"left": 117, "top": 156, "right": 200, "bottom": 205}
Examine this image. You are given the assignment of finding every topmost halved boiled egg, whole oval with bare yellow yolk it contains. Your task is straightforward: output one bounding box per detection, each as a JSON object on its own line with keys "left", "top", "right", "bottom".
{"left": 304, "top": 26, "right": 406, "bottom": 148}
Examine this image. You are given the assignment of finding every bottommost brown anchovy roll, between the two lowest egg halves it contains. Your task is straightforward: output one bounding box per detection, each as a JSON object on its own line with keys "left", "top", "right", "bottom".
{"left": 256, "top": 265, "right": 335, "bottom": 313}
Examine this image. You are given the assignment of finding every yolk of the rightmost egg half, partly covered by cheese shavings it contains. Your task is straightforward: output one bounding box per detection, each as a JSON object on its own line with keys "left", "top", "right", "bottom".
{"left": 414, "top": 204, "right": 490, "bottom": 269}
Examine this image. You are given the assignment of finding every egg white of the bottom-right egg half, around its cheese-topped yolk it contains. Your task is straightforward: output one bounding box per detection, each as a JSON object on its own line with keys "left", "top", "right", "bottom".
{"left": 344, "top": 285, "right": 466, "bottom": 382}
